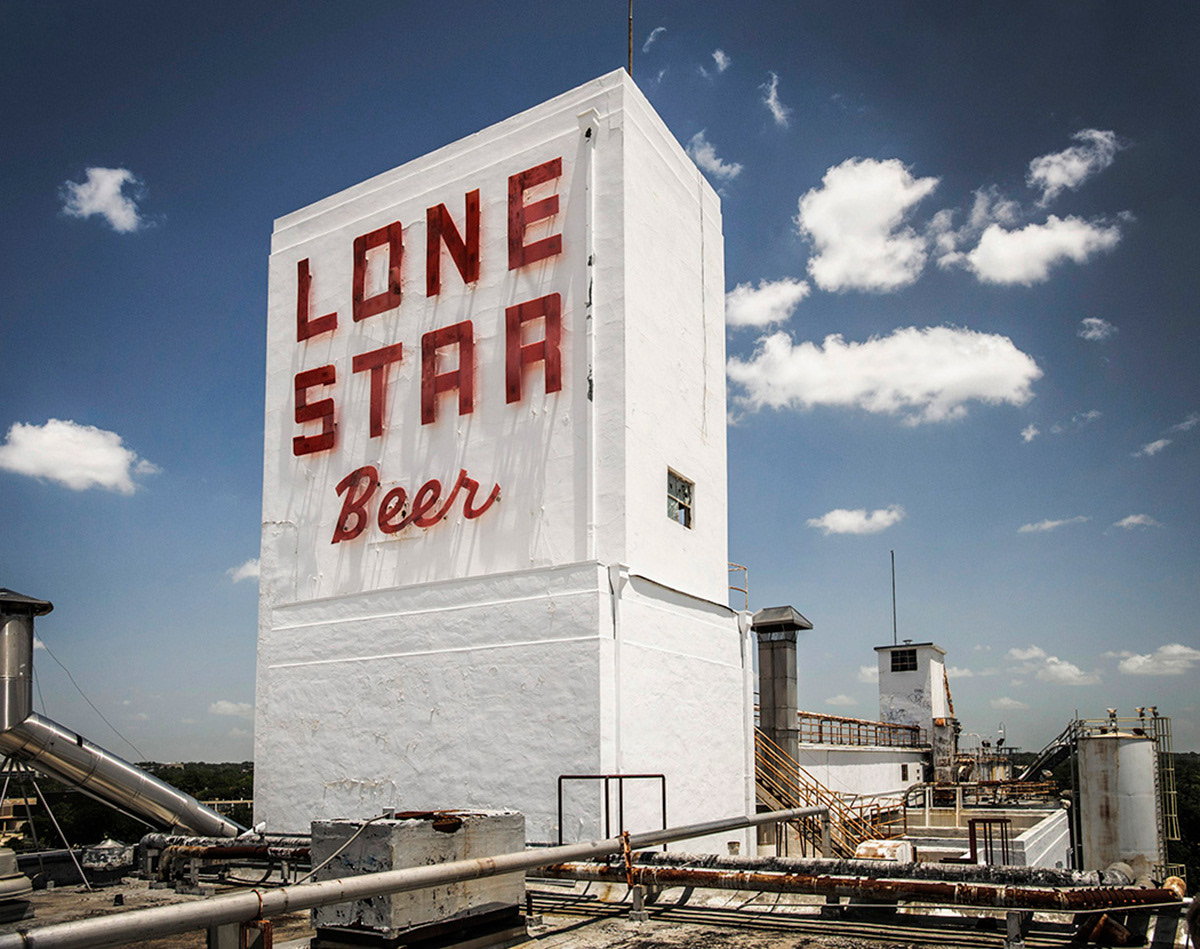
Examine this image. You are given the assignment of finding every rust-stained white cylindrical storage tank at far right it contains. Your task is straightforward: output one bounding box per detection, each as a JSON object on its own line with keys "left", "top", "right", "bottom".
{"left": 1079, "top": 732, "right": 1164, "bottom": 870}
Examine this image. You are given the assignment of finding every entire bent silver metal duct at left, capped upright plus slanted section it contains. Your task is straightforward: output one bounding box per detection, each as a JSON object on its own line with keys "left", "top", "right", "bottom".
{"left": 0, "top": 588, "right": 245, "bottom": 837}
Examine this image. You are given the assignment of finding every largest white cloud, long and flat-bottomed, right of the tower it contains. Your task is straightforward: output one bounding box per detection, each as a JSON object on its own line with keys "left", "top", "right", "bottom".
{"left": 728, "top": 326, "right": 1042, "bottom": 425}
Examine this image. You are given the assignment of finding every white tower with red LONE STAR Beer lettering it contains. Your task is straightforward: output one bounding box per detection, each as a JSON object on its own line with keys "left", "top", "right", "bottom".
{"left": 254, "top": 71, "right": 754, "bottom": 840}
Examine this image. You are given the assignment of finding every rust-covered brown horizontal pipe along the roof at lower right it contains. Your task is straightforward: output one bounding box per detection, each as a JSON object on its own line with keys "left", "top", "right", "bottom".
{"left": 541, "top": 863, "right": 1180, "bottom": 912}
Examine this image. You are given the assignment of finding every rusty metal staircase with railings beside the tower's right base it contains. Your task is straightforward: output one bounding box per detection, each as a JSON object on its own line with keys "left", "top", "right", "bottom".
{"left": 755, "top": 728, "right": 904, "bottom": 857}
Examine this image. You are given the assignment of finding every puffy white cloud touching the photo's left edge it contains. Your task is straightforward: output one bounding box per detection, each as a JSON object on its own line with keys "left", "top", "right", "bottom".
{"left": 0, "top": 419, "right": 160, "bottom": 494}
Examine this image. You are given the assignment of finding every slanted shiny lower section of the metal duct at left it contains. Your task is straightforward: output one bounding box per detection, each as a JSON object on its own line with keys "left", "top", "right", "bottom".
{"left": 0, "top": 711, "right": 245, "bottom": 837}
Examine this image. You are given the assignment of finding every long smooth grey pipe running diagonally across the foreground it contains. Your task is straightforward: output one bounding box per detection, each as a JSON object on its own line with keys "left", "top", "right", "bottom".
{"left": 0, "top": 807, "right": 826, "bottom": 949}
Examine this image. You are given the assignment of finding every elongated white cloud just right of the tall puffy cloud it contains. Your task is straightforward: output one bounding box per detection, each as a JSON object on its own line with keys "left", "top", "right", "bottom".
{"left": 962, "top": 215, "right": 1121, "bottom": 287}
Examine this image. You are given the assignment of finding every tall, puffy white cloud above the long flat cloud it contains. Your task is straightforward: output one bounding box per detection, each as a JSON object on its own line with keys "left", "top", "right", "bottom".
{"left": 797, "top": 158, "right": 938, "bottom": 293}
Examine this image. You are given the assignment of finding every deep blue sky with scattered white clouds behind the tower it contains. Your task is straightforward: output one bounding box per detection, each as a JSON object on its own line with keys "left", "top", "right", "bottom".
{"left": 0, "top": 2, "right": 1200, "bottom": 759}
